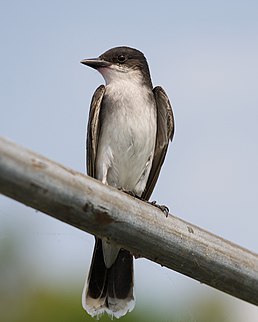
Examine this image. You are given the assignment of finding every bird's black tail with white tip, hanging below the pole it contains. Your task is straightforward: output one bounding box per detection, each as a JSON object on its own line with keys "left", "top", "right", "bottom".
{"left": 82, "top": 238, "right": 135, "bottom": 318}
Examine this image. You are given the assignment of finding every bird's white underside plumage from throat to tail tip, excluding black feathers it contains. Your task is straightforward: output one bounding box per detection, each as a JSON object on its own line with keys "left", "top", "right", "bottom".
{"left": 82, "top": 66, "right": 154, "bottom": 318}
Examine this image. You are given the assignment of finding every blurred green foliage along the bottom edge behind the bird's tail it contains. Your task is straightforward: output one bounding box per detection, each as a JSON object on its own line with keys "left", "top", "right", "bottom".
{"left": 0, "top": 289, "right": 230, "bottom": 322}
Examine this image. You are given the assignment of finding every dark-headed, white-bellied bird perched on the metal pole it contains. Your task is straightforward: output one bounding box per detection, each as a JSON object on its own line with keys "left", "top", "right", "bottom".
{"left": 81, "top": 46, "right": 175, "bottom": 318}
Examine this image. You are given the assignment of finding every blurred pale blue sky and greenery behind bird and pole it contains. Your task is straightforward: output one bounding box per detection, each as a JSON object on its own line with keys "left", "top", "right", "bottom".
{"left": 0, "top": 0, "right": 258, "bottom": 322}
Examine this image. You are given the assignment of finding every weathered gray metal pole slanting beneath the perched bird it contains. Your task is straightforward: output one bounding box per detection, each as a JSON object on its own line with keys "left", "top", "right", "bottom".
{"left": 0, "top": 138, "right": 258, "bottom": 305}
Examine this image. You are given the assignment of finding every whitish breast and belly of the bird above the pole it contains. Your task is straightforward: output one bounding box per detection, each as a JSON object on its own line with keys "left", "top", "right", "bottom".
{"left": 96, "top": 84, "right": 157, "bottom": 196}
